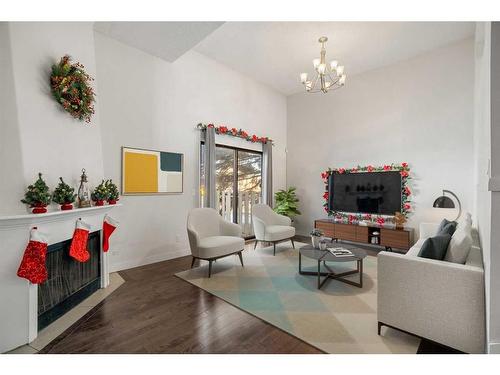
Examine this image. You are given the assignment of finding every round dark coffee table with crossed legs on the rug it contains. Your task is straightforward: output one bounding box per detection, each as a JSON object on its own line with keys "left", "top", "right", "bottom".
{"left": 299, "top": 245, "right": 366, "bottom": 289}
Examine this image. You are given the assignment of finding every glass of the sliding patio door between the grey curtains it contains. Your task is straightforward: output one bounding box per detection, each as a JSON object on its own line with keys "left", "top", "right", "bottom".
{"left": 200, "top": 144, "right": 262, "bottom": 237}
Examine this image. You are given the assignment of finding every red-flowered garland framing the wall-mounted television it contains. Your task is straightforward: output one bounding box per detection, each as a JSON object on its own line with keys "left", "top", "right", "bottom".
{"left": 321, "top": 163, "right": 412, "bottom": 226}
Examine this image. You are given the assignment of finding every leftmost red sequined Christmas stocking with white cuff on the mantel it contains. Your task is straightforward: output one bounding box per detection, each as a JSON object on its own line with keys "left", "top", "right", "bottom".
{"left": 17, "top": 228, "right": 47, "bottom": 284}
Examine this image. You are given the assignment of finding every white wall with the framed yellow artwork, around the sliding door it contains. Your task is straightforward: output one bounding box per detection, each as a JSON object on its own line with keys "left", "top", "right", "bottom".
{"left": 95, "top": 32, "right": 286, "bottom": 270}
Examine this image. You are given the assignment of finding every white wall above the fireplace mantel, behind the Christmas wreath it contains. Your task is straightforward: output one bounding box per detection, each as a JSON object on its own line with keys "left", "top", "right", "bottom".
{"left": 5, "top": 22, "right": 103, "bottom": 207}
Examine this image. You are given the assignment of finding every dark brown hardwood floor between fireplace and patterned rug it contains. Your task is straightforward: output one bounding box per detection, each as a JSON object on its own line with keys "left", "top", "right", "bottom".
{"left": 40, "top": 245, "right": 322, "bottom": 354}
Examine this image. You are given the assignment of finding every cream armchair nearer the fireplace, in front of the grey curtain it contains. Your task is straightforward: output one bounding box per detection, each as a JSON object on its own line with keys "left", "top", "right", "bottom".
{"left": 187, "top": 208, "right": 245, "bottom": 277}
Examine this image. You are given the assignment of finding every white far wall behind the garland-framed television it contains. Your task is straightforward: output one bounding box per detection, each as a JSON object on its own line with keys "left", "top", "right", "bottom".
{"left": 287, "top": 39, "right": 474, "bottom": 238}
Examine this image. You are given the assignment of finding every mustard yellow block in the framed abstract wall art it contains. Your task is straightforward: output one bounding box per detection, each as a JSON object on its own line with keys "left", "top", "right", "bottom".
{"left": 124, "top": 152, "right": 158, "bottom": 193}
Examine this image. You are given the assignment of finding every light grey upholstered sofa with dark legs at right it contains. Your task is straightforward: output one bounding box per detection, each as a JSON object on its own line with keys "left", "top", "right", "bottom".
{"left": 377, "top": 216, "right": 486, "bottom": 353}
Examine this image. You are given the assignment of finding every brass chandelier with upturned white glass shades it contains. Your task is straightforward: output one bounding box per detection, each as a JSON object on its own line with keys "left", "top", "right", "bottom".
{"left": 300, "top": 36, "right": 346, "bottom": 94}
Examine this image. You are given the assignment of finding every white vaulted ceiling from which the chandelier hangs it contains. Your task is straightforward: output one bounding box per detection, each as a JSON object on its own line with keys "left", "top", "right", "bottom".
{"left": 95, "top": 22, "right": 475, "bottom": 95}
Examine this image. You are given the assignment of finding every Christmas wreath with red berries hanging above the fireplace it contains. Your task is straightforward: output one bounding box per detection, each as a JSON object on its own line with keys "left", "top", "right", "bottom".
{"left": 50, "top": 55, "right": 95, "bottom": 122}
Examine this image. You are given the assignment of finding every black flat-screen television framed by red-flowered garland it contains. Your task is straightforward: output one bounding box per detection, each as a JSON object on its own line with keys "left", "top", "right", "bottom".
{"left": 328, "top": 171, "right": 401, "bottom": 215}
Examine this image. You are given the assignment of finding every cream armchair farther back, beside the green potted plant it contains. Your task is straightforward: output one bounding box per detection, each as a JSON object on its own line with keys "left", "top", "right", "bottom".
{"left": 252, "top": 204, "right": 295, "bottom": 255}
